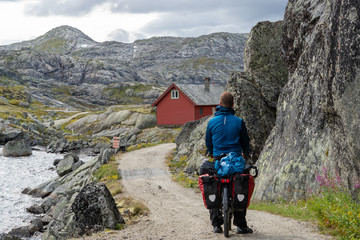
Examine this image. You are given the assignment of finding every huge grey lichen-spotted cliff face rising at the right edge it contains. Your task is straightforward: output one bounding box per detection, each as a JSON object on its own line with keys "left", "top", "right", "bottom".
{"left": 254, "top": 0, "right": 360, "bottom": 200}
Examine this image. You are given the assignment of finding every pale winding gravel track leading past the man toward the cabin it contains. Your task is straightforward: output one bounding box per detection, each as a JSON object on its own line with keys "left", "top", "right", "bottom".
{"left": 80, "top": 144, "right": 332, "bottom": 240}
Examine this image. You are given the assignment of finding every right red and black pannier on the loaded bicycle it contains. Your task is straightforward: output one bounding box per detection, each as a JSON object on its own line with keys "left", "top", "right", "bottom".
{"left": 232, "top": 174, "right": 255, "bottom": 209}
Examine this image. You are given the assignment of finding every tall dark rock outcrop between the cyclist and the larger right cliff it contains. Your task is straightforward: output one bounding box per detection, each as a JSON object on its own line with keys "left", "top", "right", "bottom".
{"left": 226, "top": 21, "right": 287, "bottom": 163}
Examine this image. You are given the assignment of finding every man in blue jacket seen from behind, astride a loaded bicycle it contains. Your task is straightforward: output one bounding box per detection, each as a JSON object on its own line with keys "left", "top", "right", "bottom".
{"left": 205, "top": 91, "right": 253, "bottom": 234}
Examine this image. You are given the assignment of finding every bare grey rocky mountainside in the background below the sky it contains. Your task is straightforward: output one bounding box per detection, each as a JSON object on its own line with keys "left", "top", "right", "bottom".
{"left": 0, "top": 26, "right": 247, "bottom": 107}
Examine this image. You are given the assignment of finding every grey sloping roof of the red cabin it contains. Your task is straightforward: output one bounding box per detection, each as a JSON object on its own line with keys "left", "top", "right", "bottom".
{"left": 176, "top": 84, "right": 225, "bottom": 105}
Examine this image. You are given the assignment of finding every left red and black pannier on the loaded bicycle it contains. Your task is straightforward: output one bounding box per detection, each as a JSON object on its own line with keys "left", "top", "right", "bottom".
{"left": 199, "top": 174, "right": 221, "bottom": 209}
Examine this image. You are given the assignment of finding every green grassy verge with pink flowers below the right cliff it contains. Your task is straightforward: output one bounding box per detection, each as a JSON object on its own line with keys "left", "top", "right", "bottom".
{"left": 249, "top": 168, "right": 360, "bottom": 239}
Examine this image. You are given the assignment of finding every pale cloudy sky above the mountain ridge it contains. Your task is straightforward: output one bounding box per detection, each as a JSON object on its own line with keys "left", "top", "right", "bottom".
{"left": 0, "top": 0, "right": 287, "bottom": 45}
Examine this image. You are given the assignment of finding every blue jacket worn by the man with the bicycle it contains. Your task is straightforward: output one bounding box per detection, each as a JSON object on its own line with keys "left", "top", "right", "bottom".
{"left": 205, "top": 106, "right": 250, "bottom": 157}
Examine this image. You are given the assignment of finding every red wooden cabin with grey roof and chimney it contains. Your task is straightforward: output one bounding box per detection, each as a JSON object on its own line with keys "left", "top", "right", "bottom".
{"left": 152, "top": 78, "right": 224, "bottom": 126}
